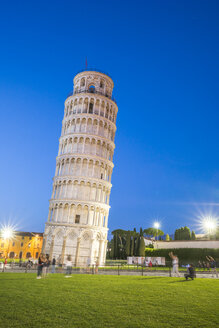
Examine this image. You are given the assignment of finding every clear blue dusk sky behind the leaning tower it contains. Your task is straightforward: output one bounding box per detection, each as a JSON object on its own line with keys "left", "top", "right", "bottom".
{"left": 0, "top": 0, "right": 219, "bottom": 234}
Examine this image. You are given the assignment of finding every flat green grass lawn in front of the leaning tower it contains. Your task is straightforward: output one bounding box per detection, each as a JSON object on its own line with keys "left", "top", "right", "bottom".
{"left": 0, "top": 273, "right": 219, "bottom": 328}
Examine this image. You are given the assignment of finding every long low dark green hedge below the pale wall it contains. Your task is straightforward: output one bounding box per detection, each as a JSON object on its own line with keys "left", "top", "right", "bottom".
{"left": 145, "top": 248, "right": 219, "bottom": 264}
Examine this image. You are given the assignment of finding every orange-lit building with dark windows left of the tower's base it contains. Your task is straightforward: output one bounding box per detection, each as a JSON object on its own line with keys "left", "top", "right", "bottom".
{"left": 0, "top": 231, "right": 43, "bottom": 259}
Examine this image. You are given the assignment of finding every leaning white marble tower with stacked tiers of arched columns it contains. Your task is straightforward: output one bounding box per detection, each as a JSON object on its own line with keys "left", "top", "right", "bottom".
{"left": 43, "top": 70, "right": 118, "bottom": 265}
